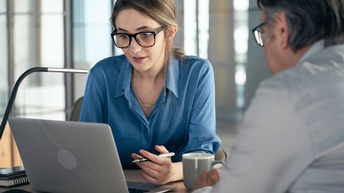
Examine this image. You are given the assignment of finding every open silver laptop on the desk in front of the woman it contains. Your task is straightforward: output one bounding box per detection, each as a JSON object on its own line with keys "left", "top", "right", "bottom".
{"left": 9, "top": 117, "right": 174, "bottom": 193}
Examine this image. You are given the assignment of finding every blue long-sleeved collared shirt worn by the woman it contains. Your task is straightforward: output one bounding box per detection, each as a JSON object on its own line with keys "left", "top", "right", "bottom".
{"left": 80, "top": 55, "right": 220, "bottom": 168}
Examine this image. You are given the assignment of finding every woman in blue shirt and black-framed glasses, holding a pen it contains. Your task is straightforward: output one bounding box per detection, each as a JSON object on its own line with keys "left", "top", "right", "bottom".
{"left": 80, "top": 0, "right": 220, "bottom": 184}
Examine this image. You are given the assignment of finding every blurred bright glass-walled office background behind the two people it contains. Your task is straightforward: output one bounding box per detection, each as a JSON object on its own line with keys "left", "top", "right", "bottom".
{"left": 0, "top": 0, "right": 270, "bottom": 167}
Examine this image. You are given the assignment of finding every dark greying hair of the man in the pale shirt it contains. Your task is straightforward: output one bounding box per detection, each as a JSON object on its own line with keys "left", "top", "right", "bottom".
{"left": 257, "top": 0, "right": 344, "bottom": 52}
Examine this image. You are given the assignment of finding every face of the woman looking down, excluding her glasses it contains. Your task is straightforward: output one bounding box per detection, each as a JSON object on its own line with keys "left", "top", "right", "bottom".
{"left": 115, "top": 9, "right": 166, "bottom": 72}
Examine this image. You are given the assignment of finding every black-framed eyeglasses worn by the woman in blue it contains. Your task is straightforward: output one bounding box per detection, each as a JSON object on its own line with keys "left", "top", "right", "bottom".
{"left": 111, "top": 26, "right": 165, "bottom": 49}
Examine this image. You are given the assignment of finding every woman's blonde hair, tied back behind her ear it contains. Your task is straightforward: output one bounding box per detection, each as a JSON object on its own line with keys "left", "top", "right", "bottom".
{"left": 111, "top": 0, "right": 185, "bottom": 61}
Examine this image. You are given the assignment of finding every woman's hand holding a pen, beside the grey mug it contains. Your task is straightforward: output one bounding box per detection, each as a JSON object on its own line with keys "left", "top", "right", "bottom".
{"left": 131, "top": 145, "right": 183, "bottom": 185}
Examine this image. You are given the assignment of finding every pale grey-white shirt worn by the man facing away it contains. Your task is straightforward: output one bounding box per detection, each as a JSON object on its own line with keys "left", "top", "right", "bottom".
{"left": 194, "top": 41, "right": 344, "bottom": 193}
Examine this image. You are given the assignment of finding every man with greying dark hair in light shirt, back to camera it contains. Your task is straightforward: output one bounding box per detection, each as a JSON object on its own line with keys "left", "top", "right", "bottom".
{"left": 194, "top": 0, "right": 344, "bottom": 193}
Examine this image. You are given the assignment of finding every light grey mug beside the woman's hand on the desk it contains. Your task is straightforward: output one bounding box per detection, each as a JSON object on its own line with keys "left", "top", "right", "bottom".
{"left": 183, "top": 152, "right": 223, "bottom": 190}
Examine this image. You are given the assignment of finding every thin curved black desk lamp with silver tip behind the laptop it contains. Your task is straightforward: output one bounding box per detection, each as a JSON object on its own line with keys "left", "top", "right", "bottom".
{"left": 0, "top": 67, "right": 88, "bottom": 139}
